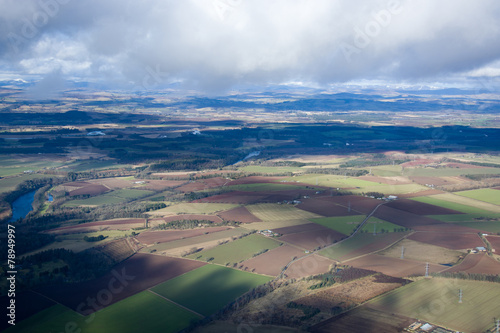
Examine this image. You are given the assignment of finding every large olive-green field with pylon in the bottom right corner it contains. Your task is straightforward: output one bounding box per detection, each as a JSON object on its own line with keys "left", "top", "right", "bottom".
{"left": 369, "top": 278, "right": 500, "bottom": 332}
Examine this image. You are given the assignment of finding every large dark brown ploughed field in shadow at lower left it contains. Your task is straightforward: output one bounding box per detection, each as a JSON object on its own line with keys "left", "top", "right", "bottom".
{"left": 36, "top": 253, "right": 205, "bottom": 315}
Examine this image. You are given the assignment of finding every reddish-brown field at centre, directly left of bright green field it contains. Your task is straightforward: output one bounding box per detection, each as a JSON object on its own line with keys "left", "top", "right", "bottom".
{"left": 278, "top": 227, "right": 345, "bottom": 251}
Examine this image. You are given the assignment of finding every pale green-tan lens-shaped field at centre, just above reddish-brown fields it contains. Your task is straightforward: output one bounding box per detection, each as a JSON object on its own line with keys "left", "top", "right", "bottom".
{"left": 245, "top": 203, "right": 319, "bottom": 221}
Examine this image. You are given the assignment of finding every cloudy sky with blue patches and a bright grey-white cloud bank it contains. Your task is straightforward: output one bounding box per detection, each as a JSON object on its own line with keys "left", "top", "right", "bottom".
{"left": 0, "top": 0, "right": 500, "bottom": 92}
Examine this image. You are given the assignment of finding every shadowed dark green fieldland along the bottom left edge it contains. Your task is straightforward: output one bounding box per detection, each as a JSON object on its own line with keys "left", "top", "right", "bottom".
{"left": 5, "top": 291, "right": 199, "bottom": 333}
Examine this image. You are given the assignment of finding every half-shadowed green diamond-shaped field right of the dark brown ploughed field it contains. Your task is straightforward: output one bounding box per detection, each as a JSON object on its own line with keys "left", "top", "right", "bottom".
{"left": 152, "top": 265, "right": 272, "bottom": 315}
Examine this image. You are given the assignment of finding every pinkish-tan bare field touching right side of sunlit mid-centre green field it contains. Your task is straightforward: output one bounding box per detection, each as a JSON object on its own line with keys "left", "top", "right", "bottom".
{"left": 242, "top": 245, "right": 305, "bottom": 276}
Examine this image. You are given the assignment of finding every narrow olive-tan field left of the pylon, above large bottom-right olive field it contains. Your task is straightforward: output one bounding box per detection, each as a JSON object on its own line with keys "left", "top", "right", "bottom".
{"left": 347, "top": 254, "right": 444, "bottom": 277}
